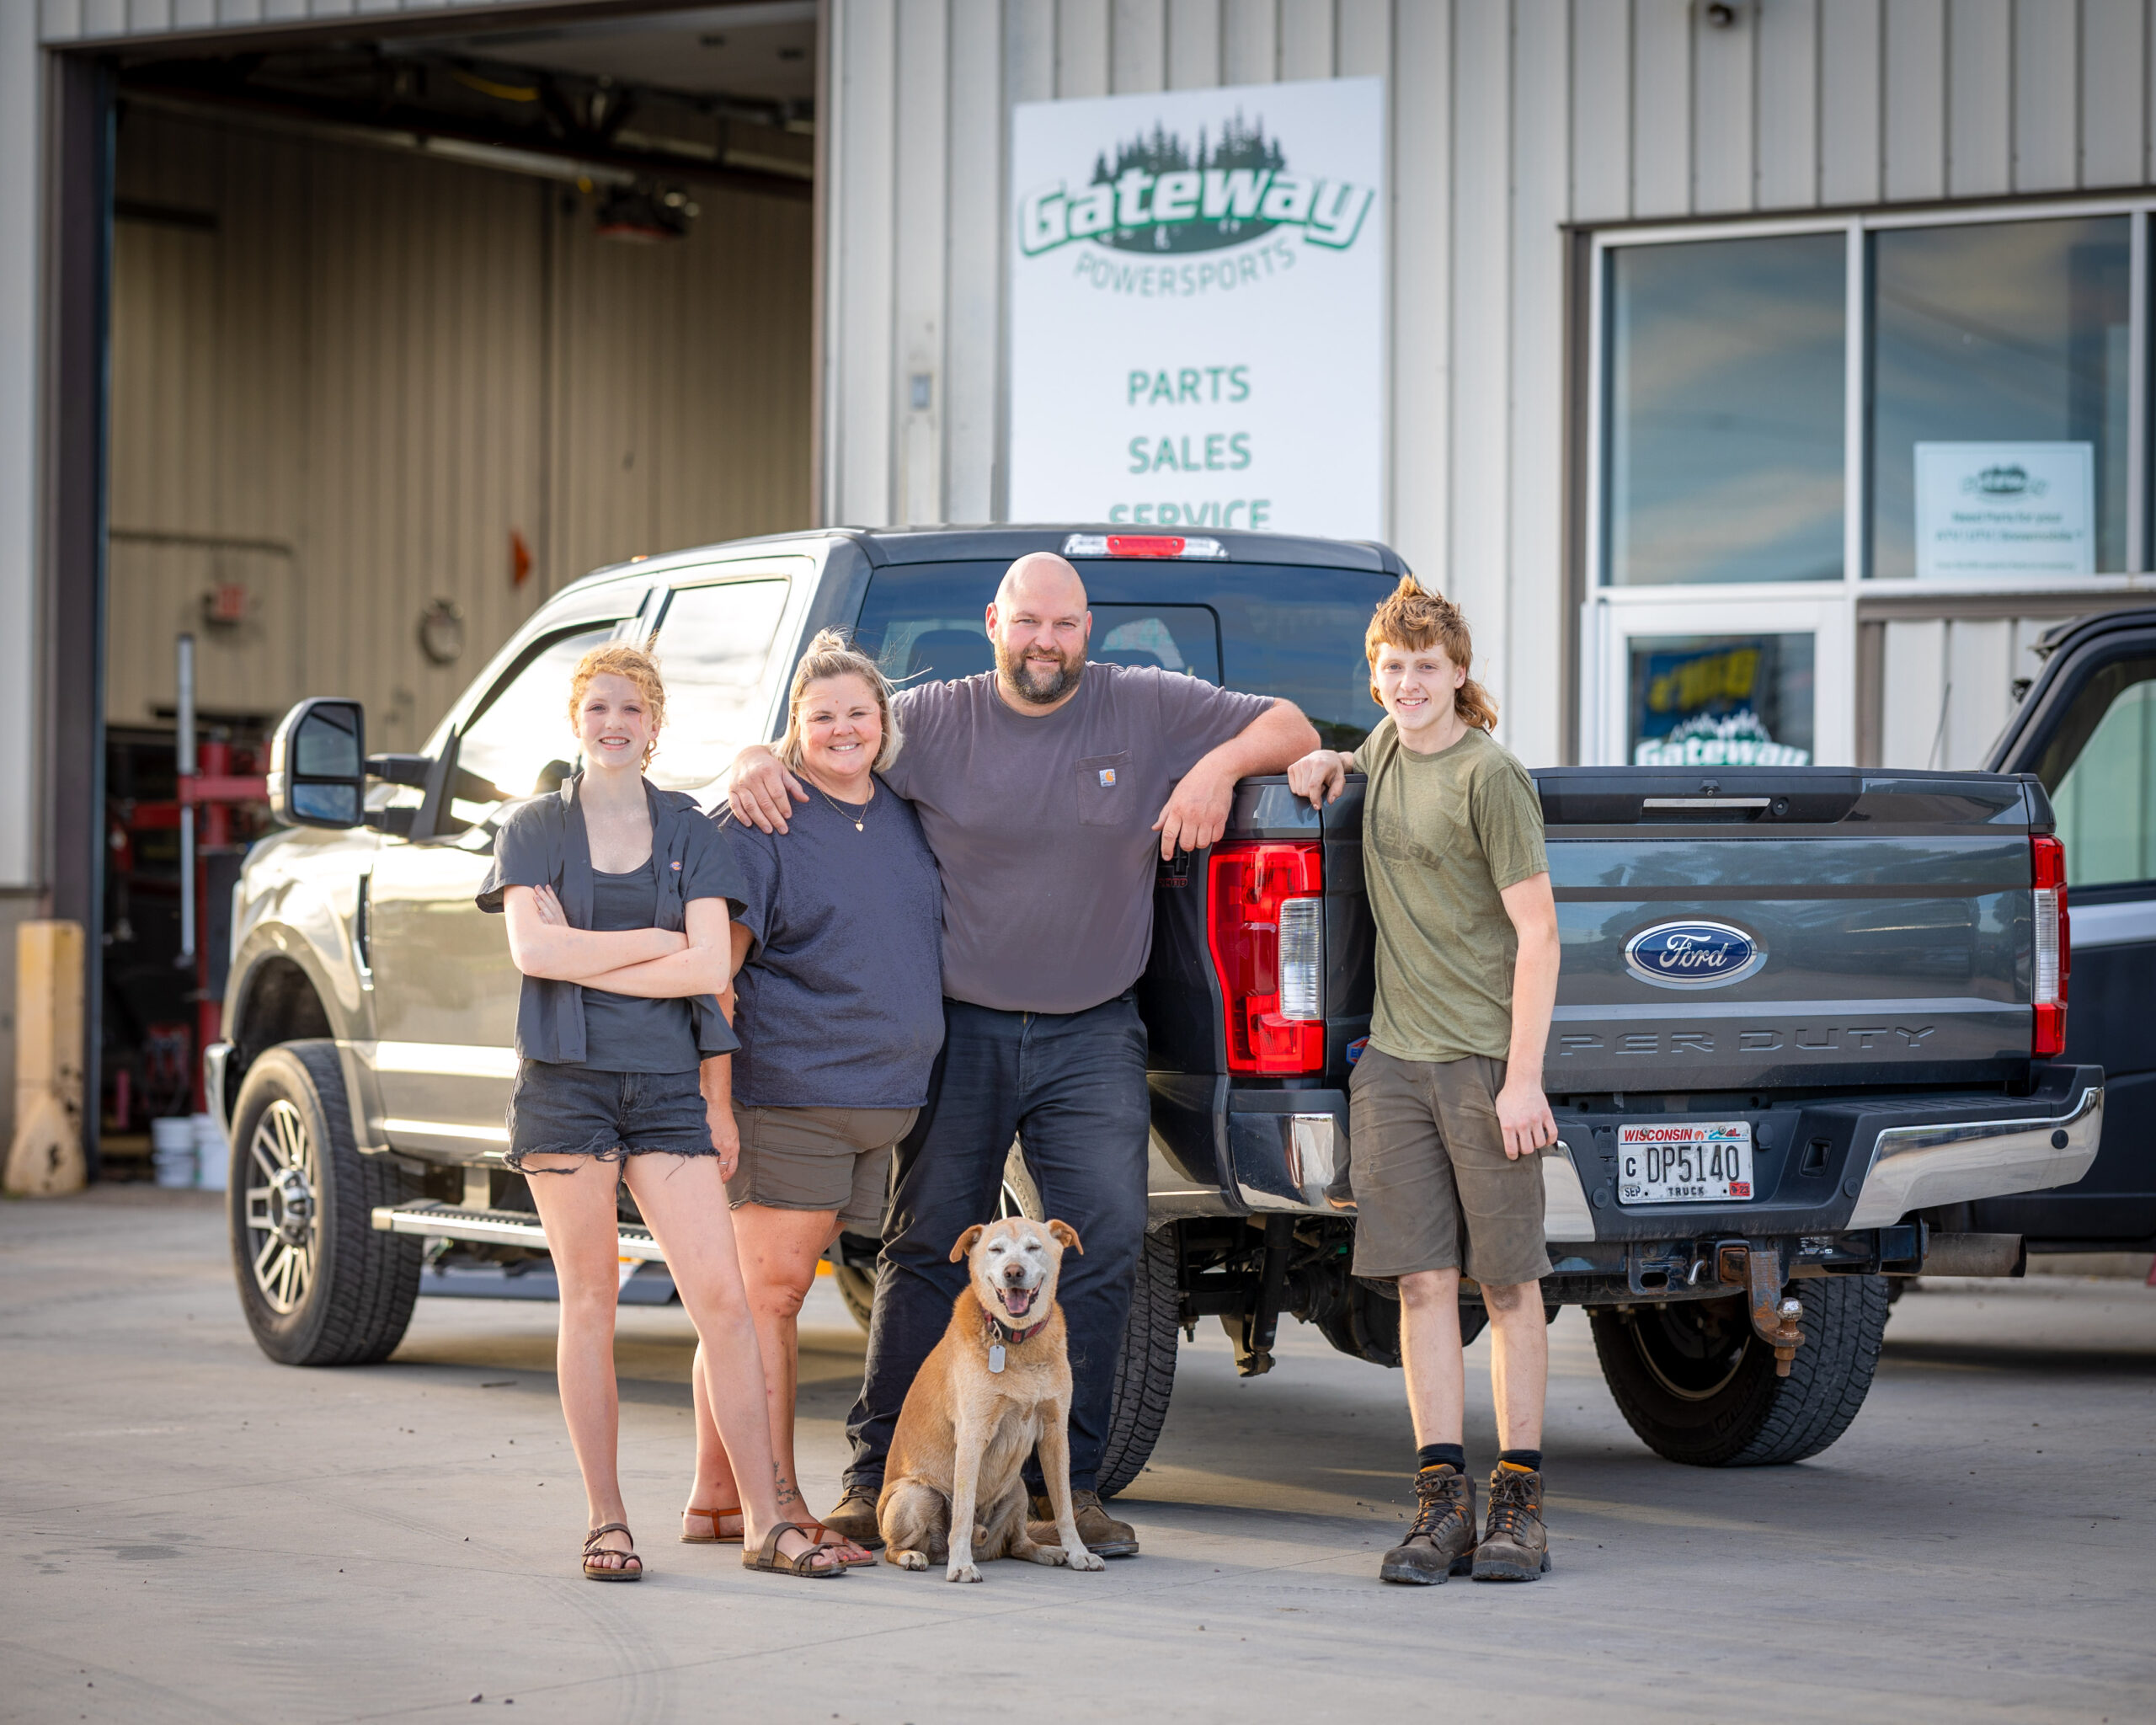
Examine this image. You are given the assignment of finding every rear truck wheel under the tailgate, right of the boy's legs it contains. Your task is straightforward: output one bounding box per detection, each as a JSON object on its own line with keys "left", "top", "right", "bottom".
{"left": 1589, "top": 1277, "right": 1886, "bottom": 1468}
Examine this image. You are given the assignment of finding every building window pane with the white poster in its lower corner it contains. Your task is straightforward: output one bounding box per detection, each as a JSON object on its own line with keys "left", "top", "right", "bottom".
{"left": 1870, "top": 216, "right": 2132, "bottom": 580}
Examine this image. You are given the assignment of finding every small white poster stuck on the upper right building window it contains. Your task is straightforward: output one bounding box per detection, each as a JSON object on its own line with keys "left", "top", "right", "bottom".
{"left": 1917, "top": 444, "right": 2095, "bottom": 576}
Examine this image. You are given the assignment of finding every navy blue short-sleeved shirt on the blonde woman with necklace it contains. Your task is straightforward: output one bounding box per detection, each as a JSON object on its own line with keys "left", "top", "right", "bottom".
{"left": 718, "top": 785, "right": 942, "bottom": 1108}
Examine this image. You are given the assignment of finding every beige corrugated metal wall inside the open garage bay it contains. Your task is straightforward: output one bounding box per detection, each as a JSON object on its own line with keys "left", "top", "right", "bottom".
{"left": 105, "top": 110, "right": 811, "bottom": 748}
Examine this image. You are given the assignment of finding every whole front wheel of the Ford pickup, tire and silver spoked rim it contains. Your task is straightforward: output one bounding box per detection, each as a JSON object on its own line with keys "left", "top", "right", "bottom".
{"left": 227, "top": 1041, "right": 420, "bottom": 1365}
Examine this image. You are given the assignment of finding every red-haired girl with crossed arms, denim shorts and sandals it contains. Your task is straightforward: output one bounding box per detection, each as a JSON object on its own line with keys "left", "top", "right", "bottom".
{"left": 478, "top": 647, "right": 843, "bottom": 1580}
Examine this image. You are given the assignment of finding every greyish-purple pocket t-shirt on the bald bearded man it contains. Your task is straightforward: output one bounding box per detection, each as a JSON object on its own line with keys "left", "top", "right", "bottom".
{"left": 884, "top": 662, "right": 1272, "bottom": 1012}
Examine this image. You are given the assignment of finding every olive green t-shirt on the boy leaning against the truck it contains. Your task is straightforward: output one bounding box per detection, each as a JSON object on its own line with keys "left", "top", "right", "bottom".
{"left": 1354, "top": 716, "right": 1550, "bottom": 1061}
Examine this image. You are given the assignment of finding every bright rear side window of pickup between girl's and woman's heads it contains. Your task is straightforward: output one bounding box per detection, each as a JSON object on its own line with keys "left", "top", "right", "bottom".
{"left": 649, "top": 578, "right": 787, "bottom": 792}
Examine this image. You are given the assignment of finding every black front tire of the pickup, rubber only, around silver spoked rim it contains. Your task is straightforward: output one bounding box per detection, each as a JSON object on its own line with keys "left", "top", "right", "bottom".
{"left": 227, "top": 1041, "right": 420, "bottom": 1365}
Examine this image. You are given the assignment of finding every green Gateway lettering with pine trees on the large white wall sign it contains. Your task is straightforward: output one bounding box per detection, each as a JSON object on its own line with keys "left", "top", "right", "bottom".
{"left": 1017, "top": 112, "right": 1378, "bottom": 257}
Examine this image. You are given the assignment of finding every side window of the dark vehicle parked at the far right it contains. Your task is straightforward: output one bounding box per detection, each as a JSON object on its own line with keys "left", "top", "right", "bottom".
{"left": 2040, "top": 658, "right": 2156, "bottom": 886}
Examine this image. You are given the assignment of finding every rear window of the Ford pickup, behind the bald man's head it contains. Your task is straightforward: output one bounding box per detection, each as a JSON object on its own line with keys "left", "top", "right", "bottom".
{"left": 856, "top": 558, "right": 1393, "bottom": 748}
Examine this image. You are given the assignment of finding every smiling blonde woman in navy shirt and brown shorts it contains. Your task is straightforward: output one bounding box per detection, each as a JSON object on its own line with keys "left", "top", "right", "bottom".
{"left": 681, "top": 630, "right": 944, "bottom": 1566}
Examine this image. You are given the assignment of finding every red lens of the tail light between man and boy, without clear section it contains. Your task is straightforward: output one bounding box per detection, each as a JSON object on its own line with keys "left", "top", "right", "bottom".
{"left": 1205, "top": 843, "right": 1326, "bottom": 1074}
